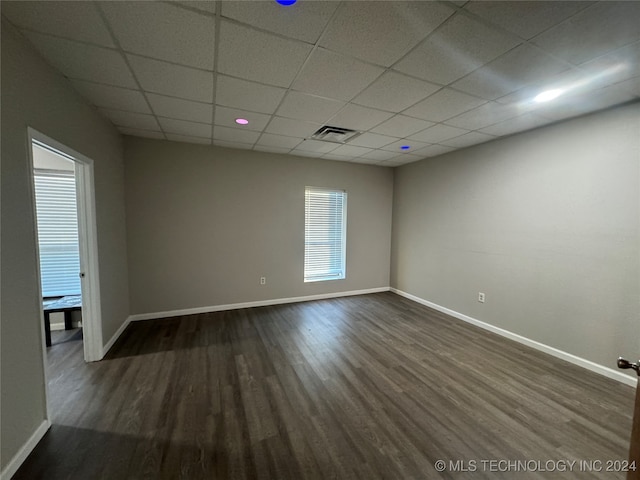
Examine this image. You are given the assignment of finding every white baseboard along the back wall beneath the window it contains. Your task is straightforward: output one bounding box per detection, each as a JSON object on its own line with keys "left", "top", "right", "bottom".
{"left": 128, "top": 287, "right": 390, "bottom": 322}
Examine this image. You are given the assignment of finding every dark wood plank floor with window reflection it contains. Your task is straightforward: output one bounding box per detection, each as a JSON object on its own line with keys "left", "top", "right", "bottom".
{"left": 14, "top": 293, "right": 634, "bottom": 480}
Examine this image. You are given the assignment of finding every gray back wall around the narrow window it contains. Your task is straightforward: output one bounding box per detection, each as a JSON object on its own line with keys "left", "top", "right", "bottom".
{"left": 125, "top": 137, "right": 393, "bottom": 314}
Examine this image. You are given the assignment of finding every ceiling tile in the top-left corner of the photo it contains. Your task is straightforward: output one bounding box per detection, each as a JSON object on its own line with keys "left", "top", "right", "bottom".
{"left": 2, "top": 1, "right": 115, "bottom": 47}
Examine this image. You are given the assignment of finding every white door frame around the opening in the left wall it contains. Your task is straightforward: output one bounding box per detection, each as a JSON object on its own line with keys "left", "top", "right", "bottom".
{"left": 27, "top": 127, "right": 103, "bottom": 372}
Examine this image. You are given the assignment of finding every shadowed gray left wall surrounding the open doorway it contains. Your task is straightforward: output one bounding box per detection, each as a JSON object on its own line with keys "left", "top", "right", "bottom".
{"left": 0, "top": 20, "right": 129, "bottom": 469}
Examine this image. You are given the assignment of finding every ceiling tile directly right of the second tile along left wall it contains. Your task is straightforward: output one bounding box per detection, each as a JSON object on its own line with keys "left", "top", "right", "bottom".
{"left": 127, "top": 55, "right": 213, "bottom": 103}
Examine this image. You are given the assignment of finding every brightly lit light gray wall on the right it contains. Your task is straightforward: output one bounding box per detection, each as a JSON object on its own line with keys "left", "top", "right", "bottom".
{"left": 391, "top": 104, "right": 640, "bottom": 368}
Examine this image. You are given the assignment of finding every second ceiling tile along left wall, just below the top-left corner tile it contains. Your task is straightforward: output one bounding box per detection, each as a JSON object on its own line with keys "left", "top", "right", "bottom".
{"left": 27, "top": 33, "right": 138, "bottom": 89}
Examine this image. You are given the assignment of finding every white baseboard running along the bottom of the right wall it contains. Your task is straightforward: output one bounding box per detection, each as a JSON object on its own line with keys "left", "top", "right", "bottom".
{"left": 389, "top": 288, "right": 637, "bottom": 387}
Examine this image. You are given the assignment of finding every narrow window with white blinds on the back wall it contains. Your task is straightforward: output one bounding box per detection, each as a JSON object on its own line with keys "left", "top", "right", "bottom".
{"left": 304, "top": 187, "right": 347, "bottom": 282}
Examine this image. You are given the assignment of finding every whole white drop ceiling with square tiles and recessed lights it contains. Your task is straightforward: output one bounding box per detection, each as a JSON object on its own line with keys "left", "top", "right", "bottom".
{"left": 0, "top": 0, "right": 640, "bottom": 166}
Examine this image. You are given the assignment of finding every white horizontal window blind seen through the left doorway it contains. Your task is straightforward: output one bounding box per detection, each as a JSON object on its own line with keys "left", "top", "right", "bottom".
{"left": 34, "top": 170, "right": 80, "bottom": 297}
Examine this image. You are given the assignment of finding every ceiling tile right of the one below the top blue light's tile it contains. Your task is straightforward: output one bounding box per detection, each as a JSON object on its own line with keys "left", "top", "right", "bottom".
{"left": 293, "top": 48, "right": 384, "bottom": 100}
